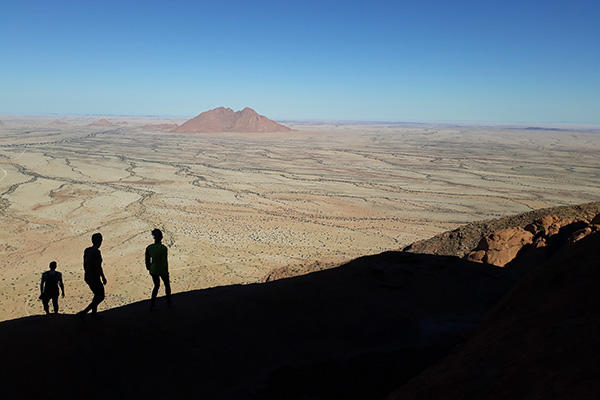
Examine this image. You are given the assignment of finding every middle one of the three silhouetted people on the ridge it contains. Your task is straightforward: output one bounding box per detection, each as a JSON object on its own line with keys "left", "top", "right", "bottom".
{"left": 79, "top": 233, "right": 106, "bottom": 318}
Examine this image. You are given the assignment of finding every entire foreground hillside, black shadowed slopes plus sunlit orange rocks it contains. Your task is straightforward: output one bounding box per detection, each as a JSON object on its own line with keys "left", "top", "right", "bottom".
{"left": 0, "top": 203, "right": 600, "bottom": 400}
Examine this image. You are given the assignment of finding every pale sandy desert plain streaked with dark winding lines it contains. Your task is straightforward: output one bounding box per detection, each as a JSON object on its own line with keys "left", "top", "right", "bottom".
{"left": 0, "top": 116, "right": 600, "bottom": 320}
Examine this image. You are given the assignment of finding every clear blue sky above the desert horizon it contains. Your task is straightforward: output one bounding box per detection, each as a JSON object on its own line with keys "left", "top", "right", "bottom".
{"left": 0, "top": 0, "right": 600, "bottom": 123}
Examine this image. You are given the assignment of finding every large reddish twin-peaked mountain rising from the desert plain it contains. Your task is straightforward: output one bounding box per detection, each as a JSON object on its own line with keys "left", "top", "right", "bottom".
{"left": 174, "top": 107, "right": 291, "bottom": 132}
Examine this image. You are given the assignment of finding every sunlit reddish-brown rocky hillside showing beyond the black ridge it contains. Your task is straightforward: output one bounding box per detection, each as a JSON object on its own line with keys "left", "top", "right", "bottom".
{"left": 263, "top": 202, "right": 600, "bottom": 282}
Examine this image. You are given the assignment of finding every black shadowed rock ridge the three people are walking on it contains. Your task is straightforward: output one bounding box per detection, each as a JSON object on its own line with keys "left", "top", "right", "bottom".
{"left": 0, "top": 252, "right": 512, "bottom": 399}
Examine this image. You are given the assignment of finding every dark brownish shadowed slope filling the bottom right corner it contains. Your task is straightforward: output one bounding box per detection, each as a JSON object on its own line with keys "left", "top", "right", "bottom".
{"left": 389, "top": 233, "right": 600, "bottom": 400}
